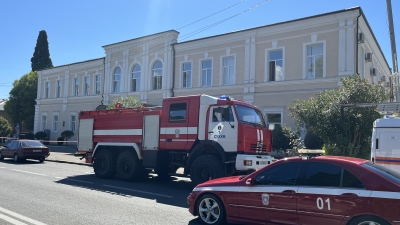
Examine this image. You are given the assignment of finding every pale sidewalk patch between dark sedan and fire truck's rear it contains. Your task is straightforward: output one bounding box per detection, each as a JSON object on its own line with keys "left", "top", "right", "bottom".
{"left": 46, "top": 145, "right": 91, "bottom": 166}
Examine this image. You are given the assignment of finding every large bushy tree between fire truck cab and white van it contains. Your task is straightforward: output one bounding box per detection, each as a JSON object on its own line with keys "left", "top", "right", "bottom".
{"left": 289, "top": 75, "right": 389, "bottom": 159}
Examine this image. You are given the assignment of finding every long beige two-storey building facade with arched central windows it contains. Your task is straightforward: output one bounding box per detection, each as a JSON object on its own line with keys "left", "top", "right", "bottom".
{"left": 35, "top": 7, "right": 390, "bottom": 143}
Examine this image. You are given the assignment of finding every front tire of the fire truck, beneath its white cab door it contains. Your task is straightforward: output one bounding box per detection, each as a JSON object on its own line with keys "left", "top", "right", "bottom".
{"left": 190, "top": 155, "right": 225, "bottom": 185}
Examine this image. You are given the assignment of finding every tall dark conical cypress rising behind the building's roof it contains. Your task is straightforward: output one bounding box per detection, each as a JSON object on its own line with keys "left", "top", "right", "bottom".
{"left": 31, "top": 30, "right": 53, "bottom": 71}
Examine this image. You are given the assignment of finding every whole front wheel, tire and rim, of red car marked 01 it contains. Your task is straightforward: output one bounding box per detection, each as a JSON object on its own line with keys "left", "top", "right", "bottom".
{"left": 196, "top": 194, "right": 226, "bottom": 225}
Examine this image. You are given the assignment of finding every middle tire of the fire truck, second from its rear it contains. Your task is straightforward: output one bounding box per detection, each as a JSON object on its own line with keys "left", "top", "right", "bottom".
{"left": 117, "top": 150, "right": 145, "bottom": 181}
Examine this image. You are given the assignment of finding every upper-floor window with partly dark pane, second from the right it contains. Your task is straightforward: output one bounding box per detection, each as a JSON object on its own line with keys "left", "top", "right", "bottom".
{"left": 268, "top": 50, "right": 283, "bottom": 81}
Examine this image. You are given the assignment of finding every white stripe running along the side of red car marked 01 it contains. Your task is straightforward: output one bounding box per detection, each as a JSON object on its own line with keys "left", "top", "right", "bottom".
{"left": 193, "top": 186, "right": 400, "bottom": 199}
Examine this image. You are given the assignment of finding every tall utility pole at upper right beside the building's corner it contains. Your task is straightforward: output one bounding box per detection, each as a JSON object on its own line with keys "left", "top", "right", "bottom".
{"left": 386, "top": 0, "right": 400, "bottom": 101}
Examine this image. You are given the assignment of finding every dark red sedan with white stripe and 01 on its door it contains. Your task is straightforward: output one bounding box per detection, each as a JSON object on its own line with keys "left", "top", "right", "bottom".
{"left": 187, "top": 156, "right": 400, "bottom": 225}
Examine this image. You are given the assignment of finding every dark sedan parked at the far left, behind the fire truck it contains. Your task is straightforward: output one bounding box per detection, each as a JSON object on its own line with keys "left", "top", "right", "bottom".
{"left": 0, "top": 140, "right": 50, "bottom": 162}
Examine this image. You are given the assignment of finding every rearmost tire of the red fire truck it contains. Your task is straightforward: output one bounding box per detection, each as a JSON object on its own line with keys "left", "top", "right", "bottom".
{"left": 93, "top": 149, "right": 116, "bottom": 179}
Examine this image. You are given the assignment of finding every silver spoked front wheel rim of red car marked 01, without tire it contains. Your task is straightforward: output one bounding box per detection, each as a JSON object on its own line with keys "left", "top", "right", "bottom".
{"left": 198, "top": 198, "right": 221, "bottom": 224}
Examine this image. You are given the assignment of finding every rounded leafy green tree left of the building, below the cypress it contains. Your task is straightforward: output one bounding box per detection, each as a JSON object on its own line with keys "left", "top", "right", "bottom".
{"left": 4, "top": 72, "right": 38, "bottom": 130}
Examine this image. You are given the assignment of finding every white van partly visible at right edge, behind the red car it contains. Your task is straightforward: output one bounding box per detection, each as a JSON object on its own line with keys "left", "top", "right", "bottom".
{"left": 371, "top": 116, "right": 400, "bottom": 172}
